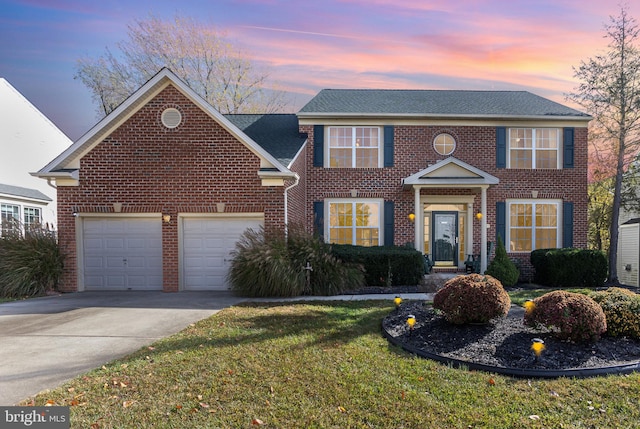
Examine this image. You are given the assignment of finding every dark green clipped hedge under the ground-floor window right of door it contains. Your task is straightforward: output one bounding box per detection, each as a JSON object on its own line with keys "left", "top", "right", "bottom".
{"left": 530, "top": 248, "right": 608, "bottom": 287}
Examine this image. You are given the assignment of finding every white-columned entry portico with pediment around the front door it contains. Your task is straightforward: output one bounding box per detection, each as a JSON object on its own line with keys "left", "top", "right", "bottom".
{"left": 402, "top": 157, "right": 499, "bottom": 272}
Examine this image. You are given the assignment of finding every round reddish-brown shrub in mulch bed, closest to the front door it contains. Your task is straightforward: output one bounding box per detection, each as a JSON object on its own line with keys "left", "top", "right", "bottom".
{"left": 433, "top": 274, "right": 511, "bottom": 325}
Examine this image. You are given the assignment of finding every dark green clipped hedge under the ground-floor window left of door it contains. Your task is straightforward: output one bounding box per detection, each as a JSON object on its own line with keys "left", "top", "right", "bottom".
{"left": 331, "top": 244, "right": 425, "bottom": 286}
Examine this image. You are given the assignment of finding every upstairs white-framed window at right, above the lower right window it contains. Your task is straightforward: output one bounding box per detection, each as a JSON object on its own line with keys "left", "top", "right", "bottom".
{"left": 508, "top": 128, "right": 562, "bottom": 169}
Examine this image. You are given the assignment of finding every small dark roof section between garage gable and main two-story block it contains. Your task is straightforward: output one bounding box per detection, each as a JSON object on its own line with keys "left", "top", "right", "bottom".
{"left": 224, "top": 114, "right": 307, "bottom": 167}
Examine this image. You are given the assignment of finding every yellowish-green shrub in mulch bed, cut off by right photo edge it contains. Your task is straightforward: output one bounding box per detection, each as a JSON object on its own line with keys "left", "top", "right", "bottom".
{"left": 590, "top": 287, "right": 640, "bottom": 339}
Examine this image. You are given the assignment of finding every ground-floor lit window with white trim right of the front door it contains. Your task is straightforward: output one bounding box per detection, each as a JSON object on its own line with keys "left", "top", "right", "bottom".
{"left": 506, "top": 200, "right": 562, "bottom": 252}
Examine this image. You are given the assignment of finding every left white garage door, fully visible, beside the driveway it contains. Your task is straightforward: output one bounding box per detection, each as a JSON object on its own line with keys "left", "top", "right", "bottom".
{"left": 82, "top": 218, "right": 162, "bottom": 290}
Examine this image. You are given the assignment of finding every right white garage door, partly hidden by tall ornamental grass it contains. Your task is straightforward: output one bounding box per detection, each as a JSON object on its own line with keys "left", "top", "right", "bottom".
{"left": 182, "top": 217, "right": 263, "bottom": 290}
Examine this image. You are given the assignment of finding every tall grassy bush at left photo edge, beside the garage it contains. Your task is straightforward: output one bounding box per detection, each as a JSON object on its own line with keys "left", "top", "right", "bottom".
{"left": 0, "top": 224, "right": 64, "bottom": 298}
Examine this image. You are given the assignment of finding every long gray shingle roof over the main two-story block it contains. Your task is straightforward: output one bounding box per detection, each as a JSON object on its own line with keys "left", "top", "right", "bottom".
{"left": 300, "top": 89, "right": 590, "bottom": 119}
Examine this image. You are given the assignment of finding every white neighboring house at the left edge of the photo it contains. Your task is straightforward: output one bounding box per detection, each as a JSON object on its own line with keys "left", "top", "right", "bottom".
{"left": 0, "top": 78, "right": 72, "bottom": 228}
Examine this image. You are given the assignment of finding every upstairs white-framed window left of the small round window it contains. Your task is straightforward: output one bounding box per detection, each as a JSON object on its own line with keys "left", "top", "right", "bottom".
{"left": 328, "top": 127, "right": 382, "bottom": 168}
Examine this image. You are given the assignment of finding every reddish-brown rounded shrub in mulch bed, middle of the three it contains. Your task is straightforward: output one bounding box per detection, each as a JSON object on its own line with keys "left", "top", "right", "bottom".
{"left": 524, "top": 290, "right": 607, "bottom": 342}
